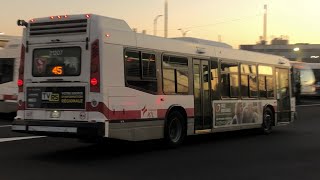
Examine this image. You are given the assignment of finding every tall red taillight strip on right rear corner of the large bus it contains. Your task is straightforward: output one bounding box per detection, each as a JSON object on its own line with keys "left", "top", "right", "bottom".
{"left": 90, "top": 39, "right": 100, "bottom": 92}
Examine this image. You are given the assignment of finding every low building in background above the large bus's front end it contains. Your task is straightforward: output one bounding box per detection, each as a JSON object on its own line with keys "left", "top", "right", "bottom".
{"left": 239, "top": 37, "right": 320, "bottom": 63}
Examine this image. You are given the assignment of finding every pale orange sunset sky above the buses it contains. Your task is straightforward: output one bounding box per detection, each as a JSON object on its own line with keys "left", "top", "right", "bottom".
{"left": 0, "top": 0, "right": 320, "bottom": 48}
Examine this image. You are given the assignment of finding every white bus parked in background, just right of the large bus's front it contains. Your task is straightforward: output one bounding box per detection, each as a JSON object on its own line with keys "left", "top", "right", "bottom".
{"left": 290, "top": 61, "right": 316, "bottom": 96}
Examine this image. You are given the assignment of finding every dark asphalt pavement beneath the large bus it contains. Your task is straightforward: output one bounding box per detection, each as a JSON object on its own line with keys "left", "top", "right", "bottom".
{"left": 0, "top": 100, "right": 320, "bottom": 180}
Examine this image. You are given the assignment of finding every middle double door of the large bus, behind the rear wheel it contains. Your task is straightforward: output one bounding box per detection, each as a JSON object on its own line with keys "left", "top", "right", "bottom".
{"left": 193, "top": 59, "right": 212, "bottom": 130}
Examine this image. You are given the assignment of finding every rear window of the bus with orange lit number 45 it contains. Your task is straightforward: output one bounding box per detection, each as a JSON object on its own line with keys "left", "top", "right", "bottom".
{"left": 32, "top": 47, "right": 81, "bottom": 77}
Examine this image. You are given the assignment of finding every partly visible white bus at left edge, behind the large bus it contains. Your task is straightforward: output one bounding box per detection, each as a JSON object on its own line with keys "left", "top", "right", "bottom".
{"left": 0, "top": 35, "right": 21, "bottom": 113}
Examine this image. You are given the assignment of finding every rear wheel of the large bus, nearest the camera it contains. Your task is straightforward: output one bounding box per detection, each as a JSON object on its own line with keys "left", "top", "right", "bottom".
{"left": 164, "top": 111, "right": 186, "bottom": 147}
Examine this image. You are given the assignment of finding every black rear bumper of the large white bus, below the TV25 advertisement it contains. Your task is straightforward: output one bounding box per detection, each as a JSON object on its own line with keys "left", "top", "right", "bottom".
{"left": 12, "top": 120, "right": 105, "bottom": 138}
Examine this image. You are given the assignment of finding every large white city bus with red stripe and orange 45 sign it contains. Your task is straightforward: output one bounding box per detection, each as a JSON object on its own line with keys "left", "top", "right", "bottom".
{"left": 12, "top": 14, "right": 295, "bottom": 145}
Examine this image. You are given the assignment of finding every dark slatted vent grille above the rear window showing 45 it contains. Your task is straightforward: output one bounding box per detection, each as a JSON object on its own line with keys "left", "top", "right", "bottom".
{"left": 30, "top": 19, "right": 88, "bottom": 36}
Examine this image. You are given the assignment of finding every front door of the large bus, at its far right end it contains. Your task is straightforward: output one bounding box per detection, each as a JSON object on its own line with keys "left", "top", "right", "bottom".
{"left": 276, "top": 68, "right": 291, "bottom": 123}
